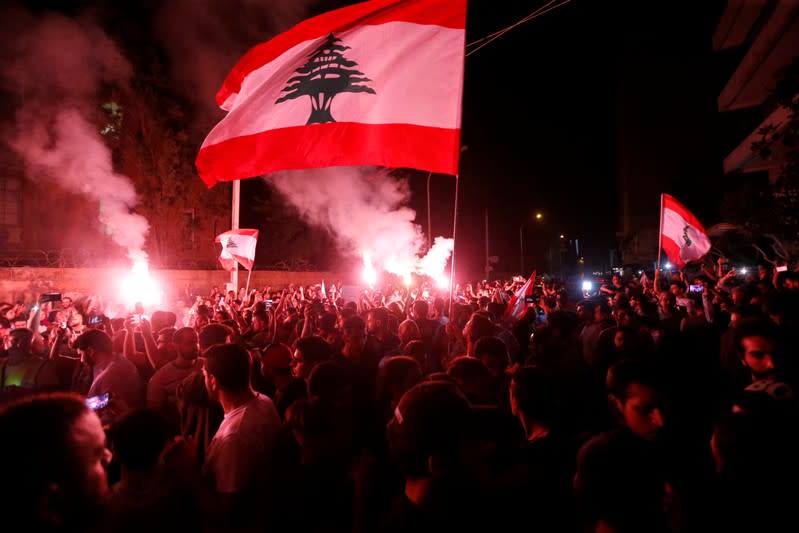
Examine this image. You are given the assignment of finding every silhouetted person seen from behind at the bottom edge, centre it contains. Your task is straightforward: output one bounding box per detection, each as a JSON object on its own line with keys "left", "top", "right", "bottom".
{"left": 380, "top": 381, "right": 500, "bottom": 532}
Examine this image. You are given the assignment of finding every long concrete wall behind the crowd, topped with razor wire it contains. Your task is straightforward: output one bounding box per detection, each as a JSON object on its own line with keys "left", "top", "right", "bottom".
{"left": 0, "top": 267, "right": 354, "bottom": 302}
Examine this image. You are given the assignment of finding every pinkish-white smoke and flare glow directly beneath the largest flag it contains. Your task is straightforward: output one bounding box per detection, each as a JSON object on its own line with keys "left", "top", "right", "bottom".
{"left": 265, "top": 167, "right": 453, "bottom": 279}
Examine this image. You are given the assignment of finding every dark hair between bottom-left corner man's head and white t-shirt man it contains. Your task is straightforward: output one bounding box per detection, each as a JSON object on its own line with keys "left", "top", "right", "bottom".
{"left": 109, "top": 409, "right": 168, "bottom": 471}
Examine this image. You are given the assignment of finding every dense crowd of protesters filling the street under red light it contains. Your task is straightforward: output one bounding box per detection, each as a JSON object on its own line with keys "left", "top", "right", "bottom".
{"left": 0, "top": 260, "right": 799, "bottom": 533}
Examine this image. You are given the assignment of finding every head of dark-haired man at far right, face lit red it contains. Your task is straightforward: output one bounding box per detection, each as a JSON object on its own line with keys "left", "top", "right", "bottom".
{"left": 735, "top": 318, "right": 779, "bottom": 381}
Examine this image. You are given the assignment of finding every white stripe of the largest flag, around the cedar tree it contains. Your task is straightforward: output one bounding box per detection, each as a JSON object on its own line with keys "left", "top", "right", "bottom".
{"left": 203, "top": 22, "right": 464, "bottom": 146}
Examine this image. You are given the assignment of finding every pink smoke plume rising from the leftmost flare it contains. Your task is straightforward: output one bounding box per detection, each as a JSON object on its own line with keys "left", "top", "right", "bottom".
{"left": 2, "top": 11, "right": 149, "bottom": 261}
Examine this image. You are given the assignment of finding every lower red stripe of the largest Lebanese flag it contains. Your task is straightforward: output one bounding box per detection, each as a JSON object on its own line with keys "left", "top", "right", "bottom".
{"left": 196, "top": 122, "right": 460, "bottom": 187}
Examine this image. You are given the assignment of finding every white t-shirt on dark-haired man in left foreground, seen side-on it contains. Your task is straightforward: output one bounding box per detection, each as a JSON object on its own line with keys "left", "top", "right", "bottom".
{"left": 203, "top": 393, "right": 280, "bottom": 494}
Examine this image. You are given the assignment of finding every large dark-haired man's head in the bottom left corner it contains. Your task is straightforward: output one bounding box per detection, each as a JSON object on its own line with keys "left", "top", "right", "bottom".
{"left": 0, "top": 393, "right": 110, "bottom": 531}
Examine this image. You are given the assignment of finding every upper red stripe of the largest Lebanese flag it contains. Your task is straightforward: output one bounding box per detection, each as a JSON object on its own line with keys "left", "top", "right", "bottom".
{"left": 216, "top": 0, "right": 466, "bottom": 106}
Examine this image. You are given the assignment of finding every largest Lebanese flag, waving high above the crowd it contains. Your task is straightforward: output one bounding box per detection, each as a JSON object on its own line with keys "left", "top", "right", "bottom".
{"left": 196, "top": 0, "right": 466, "bottom": 187}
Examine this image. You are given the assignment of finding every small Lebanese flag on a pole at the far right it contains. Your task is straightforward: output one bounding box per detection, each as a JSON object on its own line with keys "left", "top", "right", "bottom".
{"left": 660, "top": 194, "right": 711, "bottom": 268}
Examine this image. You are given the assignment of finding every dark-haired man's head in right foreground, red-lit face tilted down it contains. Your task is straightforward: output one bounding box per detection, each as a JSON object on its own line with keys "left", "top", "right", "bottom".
{"left": 605, "top": 359, "right": 664, "bottom": 440}
